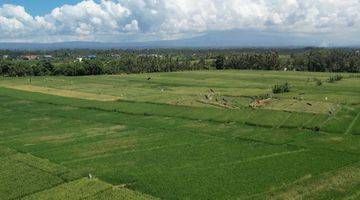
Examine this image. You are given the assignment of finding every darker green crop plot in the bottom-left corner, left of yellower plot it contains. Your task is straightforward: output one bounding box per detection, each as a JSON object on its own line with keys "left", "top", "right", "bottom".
{"left": 0, "top": 147, "right": 77, "bottom": 199}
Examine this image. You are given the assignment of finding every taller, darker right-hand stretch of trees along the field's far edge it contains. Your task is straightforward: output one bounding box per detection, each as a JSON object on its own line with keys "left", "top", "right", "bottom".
{"left": 215, "top": 50, "right": 360, "bottom": 72}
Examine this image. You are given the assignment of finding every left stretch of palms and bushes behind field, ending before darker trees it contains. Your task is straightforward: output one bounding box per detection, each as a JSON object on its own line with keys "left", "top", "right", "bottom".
{"left": 0, "top": 56, "right": 207, "bottom": 77}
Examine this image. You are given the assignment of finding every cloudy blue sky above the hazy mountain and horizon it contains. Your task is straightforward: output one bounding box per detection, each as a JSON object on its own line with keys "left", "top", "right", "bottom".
{"left": 0, "top": 0, "right": 360, "bottom": 45}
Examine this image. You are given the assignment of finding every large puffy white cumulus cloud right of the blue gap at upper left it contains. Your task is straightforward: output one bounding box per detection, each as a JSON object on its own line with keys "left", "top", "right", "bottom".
{"left": 44, "top": 0, "right": 131, "bottom": 35}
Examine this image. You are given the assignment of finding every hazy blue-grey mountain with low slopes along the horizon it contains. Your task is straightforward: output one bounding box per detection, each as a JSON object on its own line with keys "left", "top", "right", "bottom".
{"left": 0, "top": 30, "right": 360, "bottom": 50}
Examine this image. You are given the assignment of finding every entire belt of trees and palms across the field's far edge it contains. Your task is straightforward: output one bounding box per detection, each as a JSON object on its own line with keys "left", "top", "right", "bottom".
{"left": 0, "top": 49, "right": 360, "bottom": 76}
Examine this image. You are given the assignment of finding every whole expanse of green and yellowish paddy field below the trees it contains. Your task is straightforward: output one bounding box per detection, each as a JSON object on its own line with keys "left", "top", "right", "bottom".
{"left": 0, "top": 71, "right": 360, "bottom": 199}
